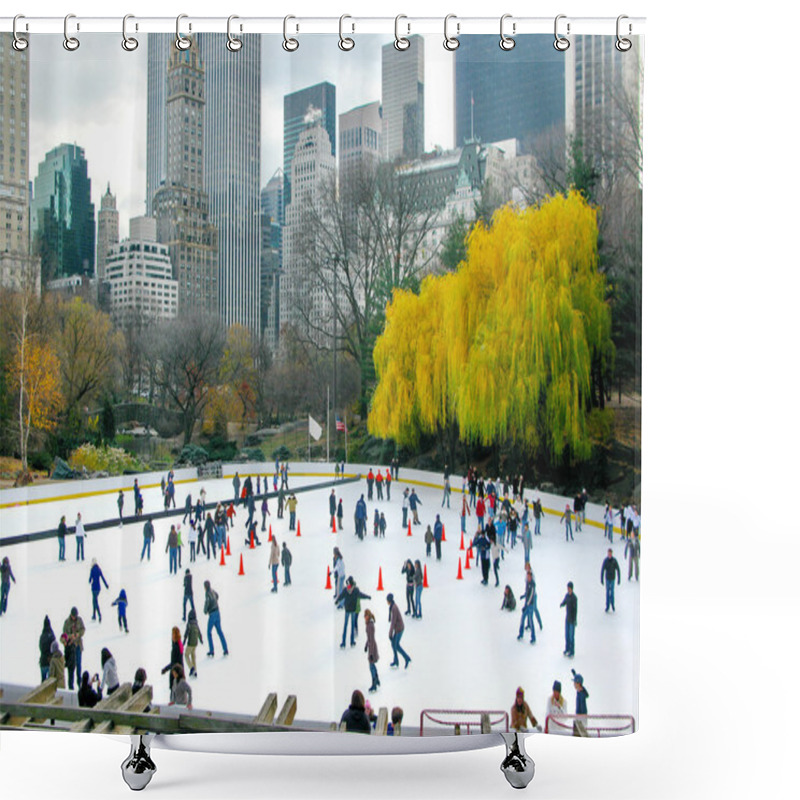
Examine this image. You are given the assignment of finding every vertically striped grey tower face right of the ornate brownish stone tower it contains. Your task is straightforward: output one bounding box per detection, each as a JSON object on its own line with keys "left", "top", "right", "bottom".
{"left": 197, "top": 33, "right": 261, "bottom": 333}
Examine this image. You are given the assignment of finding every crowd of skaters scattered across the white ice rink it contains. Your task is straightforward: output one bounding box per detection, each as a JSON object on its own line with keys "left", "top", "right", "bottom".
{"left": 2, "top": 462, "right": 640, "bottom": 732}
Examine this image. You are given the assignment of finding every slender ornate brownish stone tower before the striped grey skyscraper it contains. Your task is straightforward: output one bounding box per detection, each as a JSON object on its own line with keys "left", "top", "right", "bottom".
{"left": 153, "top": 42, "right": 219, "bottom": 315}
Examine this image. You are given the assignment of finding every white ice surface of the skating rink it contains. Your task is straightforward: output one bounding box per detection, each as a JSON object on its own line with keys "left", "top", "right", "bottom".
{"left": 0, "top": 464, "right": 646, "bottom": 731}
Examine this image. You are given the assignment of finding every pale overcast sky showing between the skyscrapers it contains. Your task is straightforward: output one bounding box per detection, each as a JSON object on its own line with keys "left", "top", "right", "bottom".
{"left": 30, "top": 34, "right": 454, "bottom": 238}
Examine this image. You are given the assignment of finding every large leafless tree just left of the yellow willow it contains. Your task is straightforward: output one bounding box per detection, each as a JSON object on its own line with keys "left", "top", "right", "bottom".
{"left": 289, "top": 164, "right": 438, "bottom": 405}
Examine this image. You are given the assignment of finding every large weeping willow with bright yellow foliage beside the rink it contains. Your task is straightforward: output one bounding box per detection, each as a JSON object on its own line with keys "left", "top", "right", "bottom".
{"left": 369, "top": 193, "right": 613, "bottom": 459}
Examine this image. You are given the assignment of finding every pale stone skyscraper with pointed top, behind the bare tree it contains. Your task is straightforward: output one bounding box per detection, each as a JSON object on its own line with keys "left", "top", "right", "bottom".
{"left": 280, "top": 119, "right": 336, "bottom": 343}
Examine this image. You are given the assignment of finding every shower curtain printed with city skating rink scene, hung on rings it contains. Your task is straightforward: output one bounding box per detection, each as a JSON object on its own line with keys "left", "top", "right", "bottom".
{"left": 0, "top": 17, "right": 643, "bottom": 768}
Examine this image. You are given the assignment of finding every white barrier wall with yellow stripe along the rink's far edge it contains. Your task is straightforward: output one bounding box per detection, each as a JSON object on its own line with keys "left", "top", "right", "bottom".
{"left": 0, "top": 461, "right": 622, "bottom": 544}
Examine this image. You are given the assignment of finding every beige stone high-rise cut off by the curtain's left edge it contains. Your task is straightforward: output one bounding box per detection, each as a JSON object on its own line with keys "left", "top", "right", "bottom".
{"left": 0, "top": 33, "right": 35, "bottom": 294}
